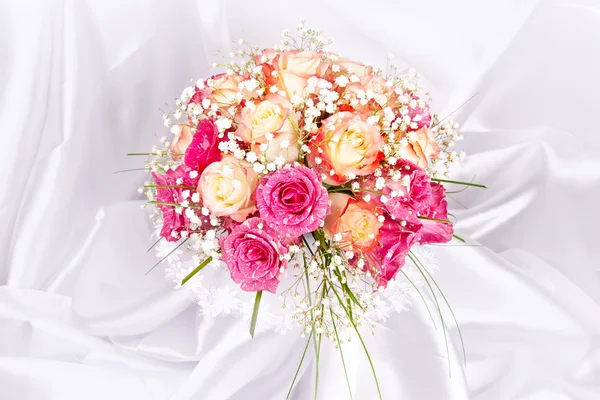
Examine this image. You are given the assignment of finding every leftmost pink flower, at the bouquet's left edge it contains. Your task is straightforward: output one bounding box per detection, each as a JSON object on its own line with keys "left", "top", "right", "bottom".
{"left": 152, "top": 165, "right": 206, "bottom": 242}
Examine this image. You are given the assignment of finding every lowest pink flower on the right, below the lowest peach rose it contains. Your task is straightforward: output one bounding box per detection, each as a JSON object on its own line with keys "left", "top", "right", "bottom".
{"left": 364, "top": 217, "right": 415, "bottom": 287}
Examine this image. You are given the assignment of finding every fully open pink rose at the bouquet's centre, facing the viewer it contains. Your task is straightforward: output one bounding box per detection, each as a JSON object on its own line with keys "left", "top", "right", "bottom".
{"left": 256, "top": 164, "right": 330, "bottom": 238}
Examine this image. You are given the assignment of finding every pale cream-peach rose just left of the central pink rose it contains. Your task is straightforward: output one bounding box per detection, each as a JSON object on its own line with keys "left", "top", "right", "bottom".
{"left": 197, "top": 156, "right": 258, "bottom": 222}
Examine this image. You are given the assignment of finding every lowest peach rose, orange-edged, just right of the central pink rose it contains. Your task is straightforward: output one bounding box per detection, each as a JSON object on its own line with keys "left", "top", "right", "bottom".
{"left": 323, "top": 193, "right": 383, "bottom": 253}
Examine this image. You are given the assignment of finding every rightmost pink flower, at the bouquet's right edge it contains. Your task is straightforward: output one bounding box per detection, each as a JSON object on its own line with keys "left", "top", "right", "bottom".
{"left": 417, "top": 183, "right": 454, "bottom": 244}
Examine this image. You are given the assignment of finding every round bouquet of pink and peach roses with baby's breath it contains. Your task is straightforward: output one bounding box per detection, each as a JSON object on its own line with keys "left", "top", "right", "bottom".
{"left": 138, "top": 24, "right": 480, "bottom": 400}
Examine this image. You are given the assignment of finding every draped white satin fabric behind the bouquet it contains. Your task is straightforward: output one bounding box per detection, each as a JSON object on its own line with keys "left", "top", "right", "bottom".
{"left": 0, "top": 0, "right": 600, "bottom": 400}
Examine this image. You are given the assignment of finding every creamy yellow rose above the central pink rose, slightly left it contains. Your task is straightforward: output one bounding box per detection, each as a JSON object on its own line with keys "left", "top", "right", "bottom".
{"left": 235, "top": 94, "right": 295, "bottom": 143}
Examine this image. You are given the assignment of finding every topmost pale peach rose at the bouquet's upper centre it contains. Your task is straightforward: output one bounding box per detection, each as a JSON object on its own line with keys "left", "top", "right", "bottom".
{"left": 273, "top": 50, "right": 328, "bottom": 99}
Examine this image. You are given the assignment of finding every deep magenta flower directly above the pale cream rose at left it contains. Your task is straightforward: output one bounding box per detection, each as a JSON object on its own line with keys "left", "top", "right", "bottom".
{"left": 184, "top": 119, "right": 221, "bottom": 173}
